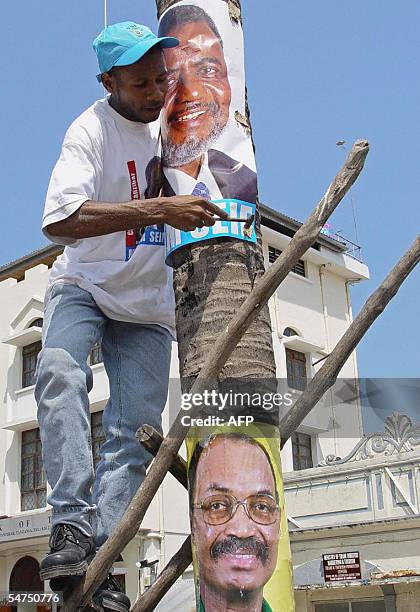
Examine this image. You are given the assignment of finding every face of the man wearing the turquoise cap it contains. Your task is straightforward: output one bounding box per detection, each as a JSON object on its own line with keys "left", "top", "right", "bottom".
{"left": 102, "top": 47, "right": 168, "bottom": 123}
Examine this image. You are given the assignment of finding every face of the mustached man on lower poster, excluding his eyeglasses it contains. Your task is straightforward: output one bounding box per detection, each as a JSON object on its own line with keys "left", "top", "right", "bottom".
{"left": 193, "top": 437, "right": 280, "bottom": 594}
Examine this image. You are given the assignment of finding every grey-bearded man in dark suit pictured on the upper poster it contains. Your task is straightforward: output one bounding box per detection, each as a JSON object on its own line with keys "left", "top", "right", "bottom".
{"left": 159, "top": 5, "right": 257, "bottom": 203}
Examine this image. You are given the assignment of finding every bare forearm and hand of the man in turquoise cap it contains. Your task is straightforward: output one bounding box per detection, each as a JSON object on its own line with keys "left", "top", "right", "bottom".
{"left": 46, "top": 196, "right": 227, "bottom": 240}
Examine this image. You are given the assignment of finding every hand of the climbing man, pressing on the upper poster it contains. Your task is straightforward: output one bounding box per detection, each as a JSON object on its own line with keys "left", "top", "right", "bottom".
{"left": 162, "top": 196, "right": 228, "bottom": 232}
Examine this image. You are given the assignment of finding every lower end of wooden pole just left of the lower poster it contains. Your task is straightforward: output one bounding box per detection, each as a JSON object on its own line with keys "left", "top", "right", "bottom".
{"left": 132, "top": 536, "right": 192, "bottom": 612}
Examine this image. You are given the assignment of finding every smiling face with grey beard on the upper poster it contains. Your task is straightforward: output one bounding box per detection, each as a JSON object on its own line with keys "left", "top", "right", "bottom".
{"left": 162, "top": 21, "right": 231, "bottom": 166}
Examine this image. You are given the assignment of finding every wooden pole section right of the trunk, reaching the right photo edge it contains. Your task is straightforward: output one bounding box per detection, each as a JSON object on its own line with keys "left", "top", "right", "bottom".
{"left": 280, "top": 237, "right": 420, "bottom": 446}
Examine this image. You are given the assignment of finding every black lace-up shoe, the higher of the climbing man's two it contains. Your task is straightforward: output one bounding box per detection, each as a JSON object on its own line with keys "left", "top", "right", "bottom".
{"left": 39, "top": 523, "right": 95, "bottom": 590}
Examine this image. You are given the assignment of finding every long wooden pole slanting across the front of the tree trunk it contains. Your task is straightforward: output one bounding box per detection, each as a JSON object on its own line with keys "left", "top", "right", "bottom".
{"left": 62, "top": 140, "right": 369, "bottom": 612}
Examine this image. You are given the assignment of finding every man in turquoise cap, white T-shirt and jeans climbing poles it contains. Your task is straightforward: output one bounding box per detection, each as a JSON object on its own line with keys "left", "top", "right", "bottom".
{"left": 35, "top": 22, "right": 224, "bottom": 612}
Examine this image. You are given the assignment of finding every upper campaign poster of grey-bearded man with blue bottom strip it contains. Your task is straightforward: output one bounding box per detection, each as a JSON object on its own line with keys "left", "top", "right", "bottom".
{"left": 159, "top": 0, "right": 257, "bottom": 265}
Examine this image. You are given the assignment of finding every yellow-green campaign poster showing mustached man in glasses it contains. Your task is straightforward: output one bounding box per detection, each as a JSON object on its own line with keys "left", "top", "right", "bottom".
{"left": 187, "top": 424, "right": 294, "bottom": 612}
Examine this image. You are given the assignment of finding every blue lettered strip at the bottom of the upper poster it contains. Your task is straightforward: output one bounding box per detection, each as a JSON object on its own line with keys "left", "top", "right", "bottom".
{"left": 165, "top": 199, "right": 257, "bottom": 266}
